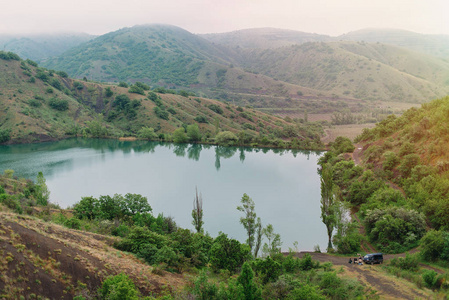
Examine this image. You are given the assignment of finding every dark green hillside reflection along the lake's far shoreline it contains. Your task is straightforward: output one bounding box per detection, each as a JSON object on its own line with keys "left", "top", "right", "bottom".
{"left": 0, "top": 138, "right": 320, "bottom": 179}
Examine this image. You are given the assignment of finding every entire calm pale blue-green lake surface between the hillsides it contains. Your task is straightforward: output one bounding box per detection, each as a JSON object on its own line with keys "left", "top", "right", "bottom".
{"left": 0, "top": 139, "right": 327, "bottom": 250}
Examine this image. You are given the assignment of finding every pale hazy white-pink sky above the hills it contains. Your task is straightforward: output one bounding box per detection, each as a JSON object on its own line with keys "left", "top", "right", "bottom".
{"left": 0, "top": 0, "right": 449, "bottom": 36}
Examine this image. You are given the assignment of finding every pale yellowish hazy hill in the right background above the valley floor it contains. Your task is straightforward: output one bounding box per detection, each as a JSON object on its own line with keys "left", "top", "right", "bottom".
{"left": 234, "top": 42, "right": 449, "bottom": 102}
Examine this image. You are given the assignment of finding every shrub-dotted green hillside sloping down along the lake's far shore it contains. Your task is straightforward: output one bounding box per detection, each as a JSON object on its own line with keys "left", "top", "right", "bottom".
{"left": 0, "top": 52, "right": 322, "bottom": 148}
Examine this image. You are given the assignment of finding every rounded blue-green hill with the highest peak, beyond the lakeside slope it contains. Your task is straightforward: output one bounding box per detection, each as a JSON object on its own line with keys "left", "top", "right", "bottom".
{"left": 43, "top": 25, "right": 319, "bottom": 105}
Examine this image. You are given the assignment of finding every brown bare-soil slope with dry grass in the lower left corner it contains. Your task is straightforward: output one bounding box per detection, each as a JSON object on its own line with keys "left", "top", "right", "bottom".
{"left": 0, "top": 212, "right": 186, "bottom": 299}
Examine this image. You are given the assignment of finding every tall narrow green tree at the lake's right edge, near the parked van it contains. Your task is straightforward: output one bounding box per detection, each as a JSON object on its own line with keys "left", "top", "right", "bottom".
{"left": 320, "top": 165, "right": 336, "bottom": 250}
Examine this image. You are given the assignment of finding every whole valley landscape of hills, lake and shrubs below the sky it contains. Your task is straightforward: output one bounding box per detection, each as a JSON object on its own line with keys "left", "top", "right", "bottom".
{"left": 0, "top": 18, "right": 449, "bottom": 300}
